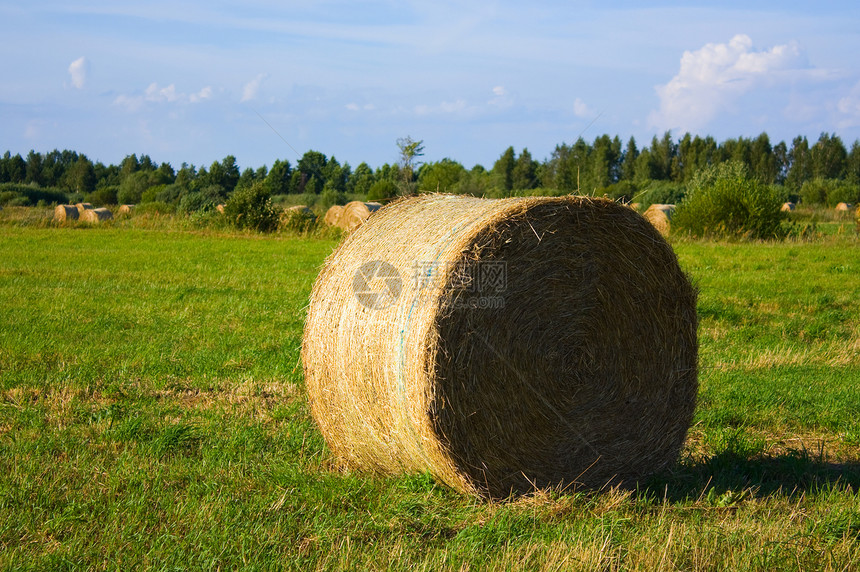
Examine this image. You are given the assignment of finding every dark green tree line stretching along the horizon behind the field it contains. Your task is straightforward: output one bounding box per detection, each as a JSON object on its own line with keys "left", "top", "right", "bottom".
{"left": 0, "top": 131, "right": 860, "bottom": 212}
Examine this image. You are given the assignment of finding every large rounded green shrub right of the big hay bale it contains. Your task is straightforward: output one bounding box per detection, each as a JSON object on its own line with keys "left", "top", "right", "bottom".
{"left": 672, "top": 163, "right": 786, "bottom": 239}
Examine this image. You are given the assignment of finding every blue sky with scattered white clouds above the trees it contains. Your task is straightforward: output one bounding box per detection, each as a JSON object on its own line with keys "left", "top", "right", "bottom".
{"left": 0, "top": 0, "right": 860, "bottom": 172}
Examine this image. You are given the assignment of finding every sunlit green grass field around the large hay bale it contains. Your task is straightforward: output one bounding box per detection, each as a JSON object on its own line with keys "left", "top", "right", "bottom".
{"left": 0, "top": 212, "right": 860, "bottom": 570}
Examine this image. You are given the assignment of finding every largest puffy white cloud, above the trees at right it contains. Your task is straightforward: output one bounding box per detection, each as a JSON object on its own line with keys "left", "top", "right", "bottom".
{"left": 649, "top": 34, "right": 814, "bottom": 131}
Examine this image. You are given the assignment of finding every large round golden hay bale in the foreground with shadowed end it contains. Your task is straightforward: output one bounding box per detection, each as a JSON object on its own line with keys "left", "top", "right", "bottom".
{"left": 302, "top": 195, "right": 698, "bottom": 498}
